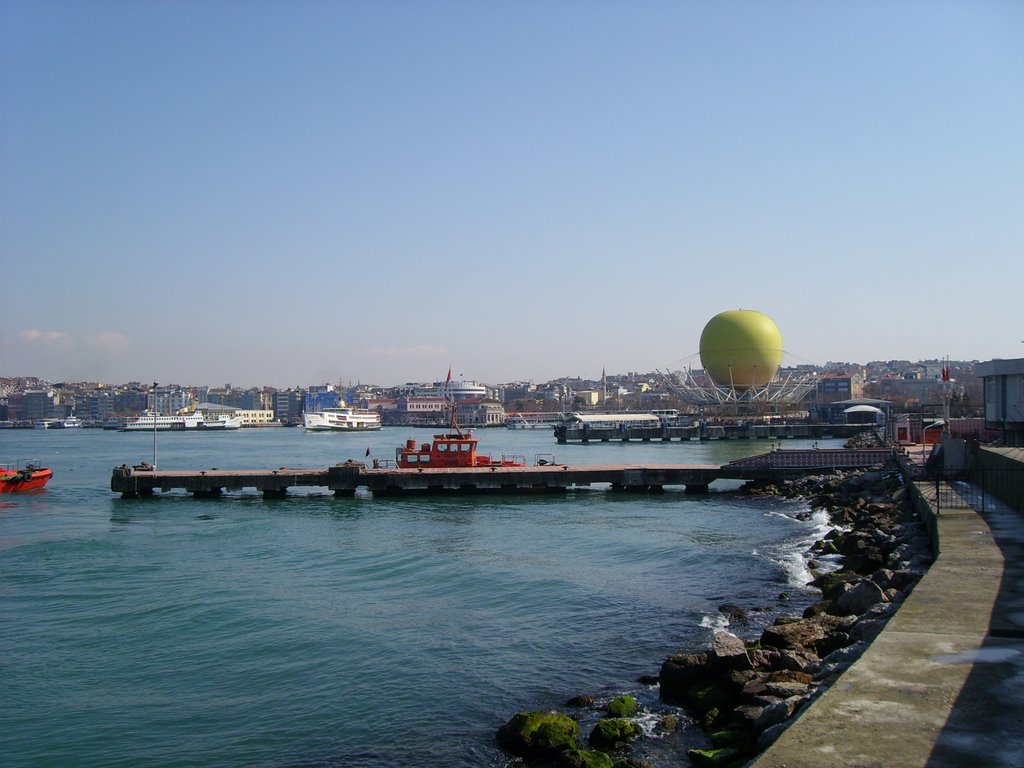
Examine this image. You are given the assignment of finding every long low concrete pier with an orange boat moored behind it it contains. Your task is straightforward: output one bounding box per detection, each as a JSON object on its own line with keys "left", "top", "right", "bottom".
{"left": 111, "top": 449, "right": 892, "bottom": 498}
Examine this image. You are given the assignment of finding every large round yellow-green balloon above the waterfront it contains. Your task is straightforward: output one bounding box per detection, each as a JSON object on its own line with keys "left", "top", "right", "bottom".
{"left": 700, "top": 309, "right": 782, "bottom": 389}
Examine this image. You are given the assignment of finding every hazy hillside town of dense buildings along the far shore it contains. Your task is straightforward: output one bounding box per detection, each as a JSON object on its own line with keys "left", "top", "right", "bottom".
{"left": 0, "top": 359, "right": 984, "bottom": 428}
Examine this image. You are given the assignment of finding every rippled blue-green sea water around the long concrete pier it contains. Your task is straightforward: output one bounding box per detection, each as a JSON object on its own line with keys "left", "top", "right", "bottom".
{"left": 0, "top": 427, "right": 839, "bottom": 768}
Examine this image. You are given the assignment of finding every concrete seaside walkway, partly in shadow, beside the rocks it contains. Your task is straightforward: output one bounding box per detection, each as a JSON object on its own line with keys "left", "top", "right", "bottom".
{"left": 751, "top": 475, "right": 1024, "bottom": 768}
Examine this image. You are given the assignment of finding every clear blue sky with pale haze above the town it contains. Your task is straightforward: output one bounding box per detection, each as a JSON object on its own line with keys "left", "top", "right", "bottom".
{"left": 0, "top": 0, "right": 1024, "bottom": 387}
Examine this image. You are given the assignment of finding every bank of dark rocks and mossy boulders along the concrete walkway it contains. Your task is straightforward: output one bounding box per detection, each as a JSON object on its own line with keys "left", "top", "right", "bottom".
{"left": 498, "top": 462, "right": 932, "bottom": 768}
